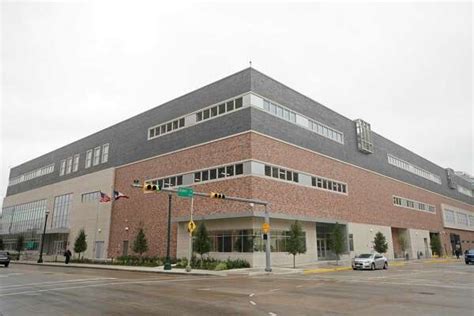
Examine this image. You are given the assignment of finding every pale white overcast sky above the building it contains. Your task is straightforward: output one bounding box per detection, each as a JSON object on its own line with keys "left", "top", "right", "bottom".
{"left": 0, "top": 1, "right": 474, "bottom": 202}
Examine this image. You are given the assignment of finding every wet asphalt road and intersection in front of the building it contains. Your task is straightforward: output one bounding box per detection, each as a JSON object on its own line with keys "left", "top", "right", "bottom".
{"left": 0, "top": 262, "right": 474, "bottom": 316}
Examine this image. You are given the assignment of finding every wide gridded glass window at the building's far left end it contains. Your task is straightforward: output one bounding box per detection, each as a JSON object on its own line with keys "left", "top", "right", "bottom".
{"left": 0, "top": 200, "right": 46, "bottom": 234}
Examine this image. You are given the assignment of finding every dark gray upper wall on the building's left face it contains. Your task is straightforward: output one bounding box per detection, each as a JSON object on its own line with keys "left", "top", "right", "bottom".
{"left": 7, "top": 69, "right": 250, "bottom": 196}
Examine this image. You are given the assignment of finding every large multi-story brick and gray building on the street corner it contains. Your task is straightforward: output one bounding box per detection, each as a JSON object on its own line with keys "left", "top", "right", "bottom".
{"left": 2, "top": 68, "right": 474, "bottom": 266}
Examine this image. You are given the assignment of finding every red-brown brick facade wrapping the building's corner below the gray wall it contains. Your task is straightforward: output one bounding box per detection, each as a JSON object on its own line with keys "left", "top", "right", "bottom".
{"left": 109, "top": 132, "right": 474, "bottom": 257}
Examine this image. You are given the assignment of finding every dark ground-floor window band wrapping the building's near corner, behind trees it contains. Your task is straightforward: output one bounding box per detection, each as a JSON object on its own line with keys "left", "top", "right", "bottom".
{"left": 209, "top": 229, "right": 306, "bottom": 252}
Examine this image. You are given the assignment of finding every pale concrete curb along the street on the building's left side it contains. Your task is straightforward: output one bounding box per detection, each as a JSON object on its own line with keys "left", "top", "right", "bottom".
{"left": 11, "top": 261, "right": 227, "bottom": 276}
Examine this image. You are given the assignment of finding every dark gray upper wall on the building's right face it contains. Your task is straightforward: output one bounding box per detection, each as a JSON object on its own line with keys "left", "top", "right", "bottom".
{"left": 252, "top": 69, "right": 474, "bottom": 204}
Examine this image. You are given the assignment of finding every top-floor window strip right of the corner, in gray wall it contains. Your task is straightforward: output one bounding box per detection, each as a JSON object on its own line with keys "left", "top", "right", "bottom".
{"left": 252, "top": 95, "right": 344, "bottom": 144}
